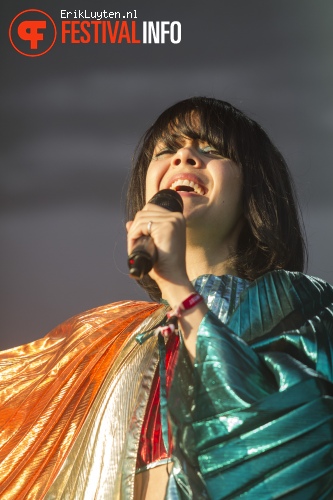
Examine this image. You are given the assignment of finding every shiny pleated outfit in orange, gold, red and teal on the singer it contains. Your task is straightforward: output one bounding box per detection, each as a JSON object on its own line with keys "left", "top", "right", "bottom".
{"left": 0, "top": 271, "right": 333, "bottom": 500}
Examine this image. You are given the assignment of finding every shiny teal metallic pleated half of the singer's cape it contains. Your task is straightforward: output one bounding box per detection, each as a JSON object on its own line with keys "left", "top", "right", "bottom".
{"left": 167, "top": 271, "right": 333, "bottom": 500}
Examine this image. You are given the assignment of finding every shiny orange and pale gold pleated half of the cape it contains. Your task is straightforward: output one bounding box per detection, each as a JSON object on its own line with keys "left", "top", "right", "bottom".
{"left": 0, "top": 302, "right": 165, "bottom": 500}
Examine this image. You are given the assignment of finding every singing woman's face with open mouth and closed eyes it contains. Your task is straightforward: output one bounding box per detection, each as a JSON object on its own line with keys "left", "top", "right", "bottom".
{"left": 146, "top": 131, "right": 243, "bottom": 241}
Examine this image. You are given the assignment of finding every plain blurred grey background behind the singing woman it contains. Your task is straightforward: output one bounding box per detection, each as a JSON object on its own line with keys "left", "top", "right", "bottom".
{"left": 0, "top": 0, "right": 333, "bottom": 349}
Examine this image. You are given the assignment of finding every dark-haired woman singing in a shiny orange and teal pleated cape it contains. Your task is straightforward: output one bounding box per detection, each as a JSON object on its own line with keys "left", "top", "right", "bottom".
{"left": 0, "top": 97, "right": 333, "bottom": 500}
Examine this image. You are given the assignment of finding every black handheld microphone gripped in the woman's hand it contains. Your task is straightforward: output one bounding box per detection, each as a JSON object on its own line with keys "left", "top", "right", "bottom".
{"left": 127, "top": 189, "right": 184, "bottom": 280}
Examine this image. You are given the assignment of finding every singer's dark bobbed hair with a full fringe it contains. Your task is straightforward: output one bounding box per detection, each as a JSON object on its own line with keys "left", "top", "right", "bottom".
{"left": 127, "top": 97, "right": 307, "bottom": 300}
